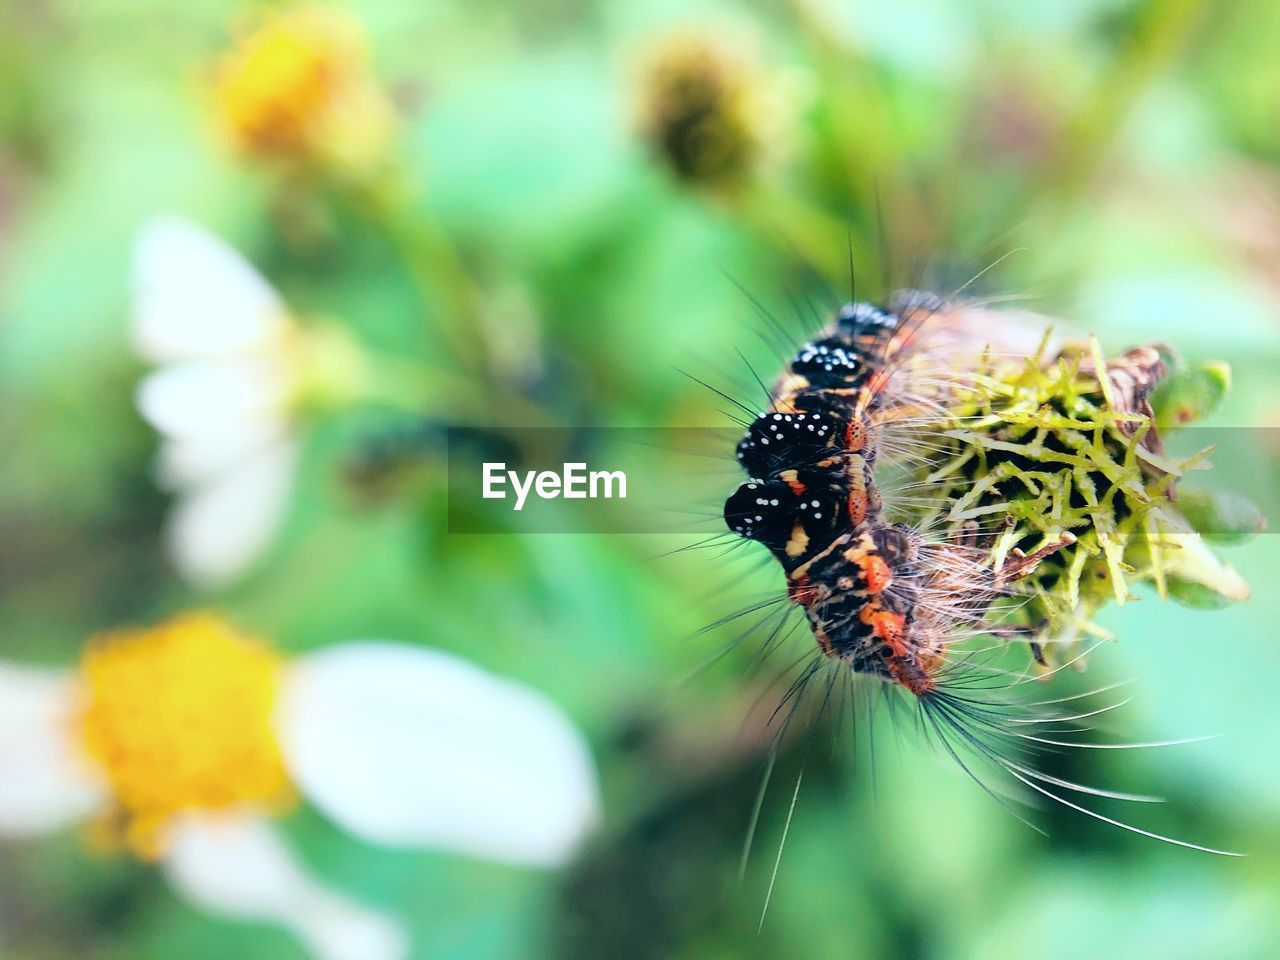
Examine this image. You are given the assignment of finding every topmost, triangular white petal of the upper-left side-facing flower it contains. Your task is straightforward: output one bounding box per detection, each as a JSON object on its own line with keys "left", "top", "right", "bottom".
{"left": 133, "top": 216, "right": 287, "bottom": 362}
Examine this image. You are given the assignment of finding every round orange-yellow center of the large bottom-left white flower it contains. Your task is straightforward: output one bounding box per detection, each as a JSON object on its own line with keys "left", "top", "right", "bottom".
{"left": 79, "top": 613, "right": 294, "bottom": 858}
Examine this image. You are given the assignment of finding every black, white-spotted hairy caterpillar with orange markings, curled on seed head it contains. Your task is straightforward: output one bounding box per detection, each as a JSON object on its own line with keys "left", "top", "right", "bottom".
{"left": 724, "top": 291, "right": 1064, "bottom": 696}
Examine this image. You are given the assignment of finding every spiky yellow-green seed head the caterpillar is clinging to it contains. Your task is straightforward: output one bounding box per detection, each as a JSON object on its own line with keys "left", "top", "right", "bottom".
{"left": 902, "top": 335, "right": 1256, "bottom": 662}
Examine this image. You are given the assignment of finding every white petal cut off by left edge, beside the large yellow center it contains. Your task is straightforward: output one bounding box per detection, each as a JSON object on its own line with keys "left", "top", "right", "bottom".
{"left": 0, "top": 664, "right": 104, "bottom": 836}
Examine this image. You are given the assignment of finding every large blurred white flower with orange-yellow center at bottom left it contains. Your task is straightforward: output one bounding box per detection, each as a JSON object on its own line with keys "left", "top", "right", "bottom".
{"left": 0, "top": 614, "right": 598, "bottom": 960}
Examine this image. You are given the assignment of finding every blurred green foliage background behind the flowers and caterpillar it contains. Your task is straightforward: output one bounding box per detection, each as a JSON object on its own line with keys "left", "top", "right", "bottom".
{"left": 0, "top": 0, "right": 1280, "bottom": 960}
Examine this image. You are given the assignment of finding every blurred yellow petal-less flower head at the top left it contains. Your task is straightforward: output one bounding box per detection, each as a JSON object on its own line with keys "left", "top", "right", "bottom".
{"left": 215, "top": 6, "right": 396, "bottom": 177}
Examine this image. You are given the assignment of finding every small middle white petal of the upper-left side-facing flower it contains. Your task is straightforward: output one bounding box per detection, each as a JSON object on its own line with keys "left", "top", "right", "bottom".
{"left": 136, "top": 358, "right": 289, "bottom": 439}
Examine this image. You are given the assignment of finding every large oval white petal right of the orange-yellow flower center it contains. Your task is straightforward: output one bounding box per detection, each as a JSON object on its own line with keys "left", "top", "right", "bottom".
{"left": 279, "top": 643, "right": 598, "bottom": 867}
